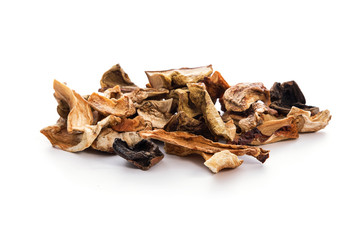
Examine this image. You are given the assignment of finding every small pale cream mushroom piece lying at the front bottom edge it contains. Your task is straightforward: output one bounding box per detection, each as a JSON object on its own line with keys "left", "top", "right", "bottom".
{"left": 204, "top": 150, "right": 244, "bottom": 173}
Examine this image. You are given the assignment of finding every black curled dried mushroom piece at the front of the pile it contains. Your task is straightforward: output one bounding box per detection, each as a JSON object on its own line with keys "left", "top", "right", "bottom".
{"left": 113, "top": 138, "right": 164, "bottom": 170}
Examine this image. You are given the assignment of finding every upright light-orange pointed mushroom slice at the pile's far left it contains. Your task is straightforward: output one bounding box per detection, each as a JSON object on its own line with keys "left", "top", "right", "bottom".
{"left": 53, "top": 80, "right": 93, "bottom": 133}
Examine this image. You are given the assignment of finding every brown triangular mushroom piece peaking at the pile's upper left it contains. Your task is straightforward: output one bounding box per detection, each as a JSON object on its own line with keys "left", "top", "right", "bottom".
{"left": 100, "top": 64, "right": 136, "bottom": 89}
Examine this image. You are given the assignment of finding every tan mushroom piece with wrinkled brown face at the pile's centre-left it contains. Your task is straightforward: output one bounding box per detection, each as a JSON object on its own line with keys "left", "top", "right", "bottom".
{"left": 136, "top": 99, "right": 172, "bottom": 128}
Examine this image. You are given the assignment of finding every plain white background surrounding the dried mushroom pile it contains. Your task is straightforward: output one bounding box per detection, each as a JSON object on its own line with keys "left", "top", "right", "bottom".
{"left": 0, "top": 0, "right": 360, "bottom": 239}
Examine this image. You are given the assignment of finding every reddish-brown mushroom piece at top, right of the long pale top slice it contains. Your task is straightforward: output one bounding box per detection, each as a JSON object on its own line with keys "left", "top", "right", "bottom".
{"left": 204, "top": 71, "right": 230, "bottom": 103}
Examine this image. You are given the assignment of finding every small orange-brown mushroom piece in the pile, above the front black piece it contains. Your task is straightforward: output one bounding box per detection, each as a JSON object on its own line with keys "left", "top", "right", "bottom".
{"left": 111, "top": 116, "right": 152, "bottom": 132}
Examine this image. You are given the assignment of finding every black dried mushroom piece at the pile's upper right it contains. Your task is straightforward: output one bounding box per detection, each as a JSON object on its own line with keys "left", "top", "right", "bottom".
{"left": 270, "top": 81, "right": 319, "bottom": 115}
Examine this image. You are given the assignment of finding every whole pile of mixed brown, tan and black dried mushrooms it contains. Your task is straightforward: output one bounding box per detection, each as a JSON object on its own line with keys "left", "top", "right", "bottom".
{"left": 41, "top": 64, "right": 331, "bottom": 173}
